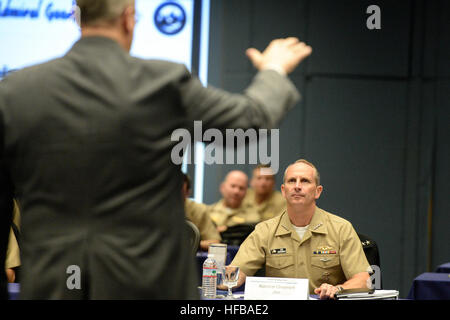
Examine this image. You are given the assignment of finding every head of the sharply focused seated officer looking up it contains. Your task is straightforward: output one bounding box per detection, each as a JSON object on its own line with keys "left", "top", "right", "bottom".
{"left": 281, "top": 163, "right": 323, "bottom": 206}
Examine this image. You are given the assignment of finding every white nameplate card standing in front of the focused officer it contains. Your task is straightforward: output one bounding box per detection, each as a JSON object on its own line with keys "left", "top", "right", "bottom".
{"left": 244, "top": 277, "right": 309, "bottom": 300}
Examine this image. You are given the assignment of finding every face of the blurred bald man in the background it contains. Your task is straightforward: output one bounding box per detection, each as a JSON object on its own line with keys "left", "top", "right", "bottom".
{"left": 220, "top": 172, "right": 248, "bottom": 208}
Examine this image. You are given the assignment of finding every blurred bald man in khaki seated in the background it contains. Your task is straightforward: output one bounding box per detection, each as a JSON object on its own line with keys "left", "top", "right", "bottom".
{"left": 209, "top": 170, "right": 261, "bottom": 232}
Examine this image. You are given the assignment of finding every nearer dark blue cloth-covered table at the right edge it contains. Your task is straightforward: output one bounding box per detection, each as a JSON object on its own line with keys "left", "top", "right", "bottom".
{"left": 408, "top": 272, "right": 450, "bottom": 300}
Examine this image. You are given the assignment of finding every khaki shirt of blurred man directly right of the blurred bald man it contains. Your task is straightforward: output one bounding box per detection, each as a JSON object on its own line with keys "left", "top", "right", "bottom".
{"left": 244, "top": 189, "right": 286, "bottom": 221}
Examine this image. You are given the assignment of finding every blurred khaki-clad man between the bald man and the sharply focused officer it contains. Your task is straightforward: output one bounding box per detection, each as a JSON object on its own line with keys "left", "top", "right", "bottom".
{"left": 244, "top": 164, "right": 286, "bottom": 221}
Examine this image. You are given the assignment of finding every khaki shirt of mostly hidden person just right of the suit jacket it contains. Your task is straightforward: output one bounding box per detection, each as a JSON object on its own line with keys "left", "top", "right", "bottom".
{"left": 184, "top": 199, "right": 222, "bottom": 241}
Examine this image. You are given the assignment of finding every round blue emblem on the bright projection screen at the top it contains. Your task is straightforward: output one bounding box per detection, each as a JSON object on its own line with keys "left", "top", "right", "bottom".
{"left": 153, "top": 2, "right": 186, "bottom": 35}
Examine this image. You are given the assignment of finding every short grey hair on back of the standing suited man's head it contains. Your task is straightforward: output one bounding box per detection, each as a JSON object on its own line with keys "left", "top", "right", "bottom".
{"left": 77, "top": 0, "right": 135, "bottom": 26}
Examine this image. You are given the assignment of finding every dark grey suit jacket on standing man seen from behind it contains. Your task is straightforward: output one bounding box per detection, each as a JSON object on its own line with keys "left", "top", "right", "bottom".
{"left": 0, "top": 37, "right": 299, "bottom": 299}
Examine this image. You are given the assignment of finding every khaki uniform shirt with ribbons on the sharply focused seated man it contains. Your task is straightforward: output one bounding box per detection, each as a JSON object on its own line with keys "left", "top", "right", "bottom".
{"left": 231, "top": 208, "right": 370, "bottom": 293}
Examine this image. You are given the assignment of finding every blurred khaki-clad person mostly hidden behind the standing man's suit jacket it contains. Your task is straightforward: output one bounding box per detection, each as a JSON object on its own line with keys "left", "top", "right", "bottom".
{"left": 182, "top": 173, "right": 222, "bottom": 251}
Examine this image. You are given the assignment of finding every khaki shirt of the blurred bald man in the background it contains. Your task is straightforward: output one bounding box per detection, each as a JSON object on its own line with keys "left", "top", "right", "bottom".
{"left": 209, "top": 199, "right": 261, "bottom": 227}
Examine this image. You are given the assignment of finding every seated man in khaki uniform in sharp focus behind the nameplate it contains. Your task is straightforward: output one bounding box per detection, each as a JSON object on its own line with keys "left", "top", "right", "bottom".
{"left": 227, "top": 159, "right": 370, "bottom": 299}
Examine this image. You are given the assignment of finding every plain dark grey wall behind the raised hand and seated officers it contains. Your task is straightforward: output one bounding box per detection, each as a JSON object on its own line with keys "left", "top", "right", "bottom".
{"left": 200, "top": 0, "right": 450, "bottom": 297}
